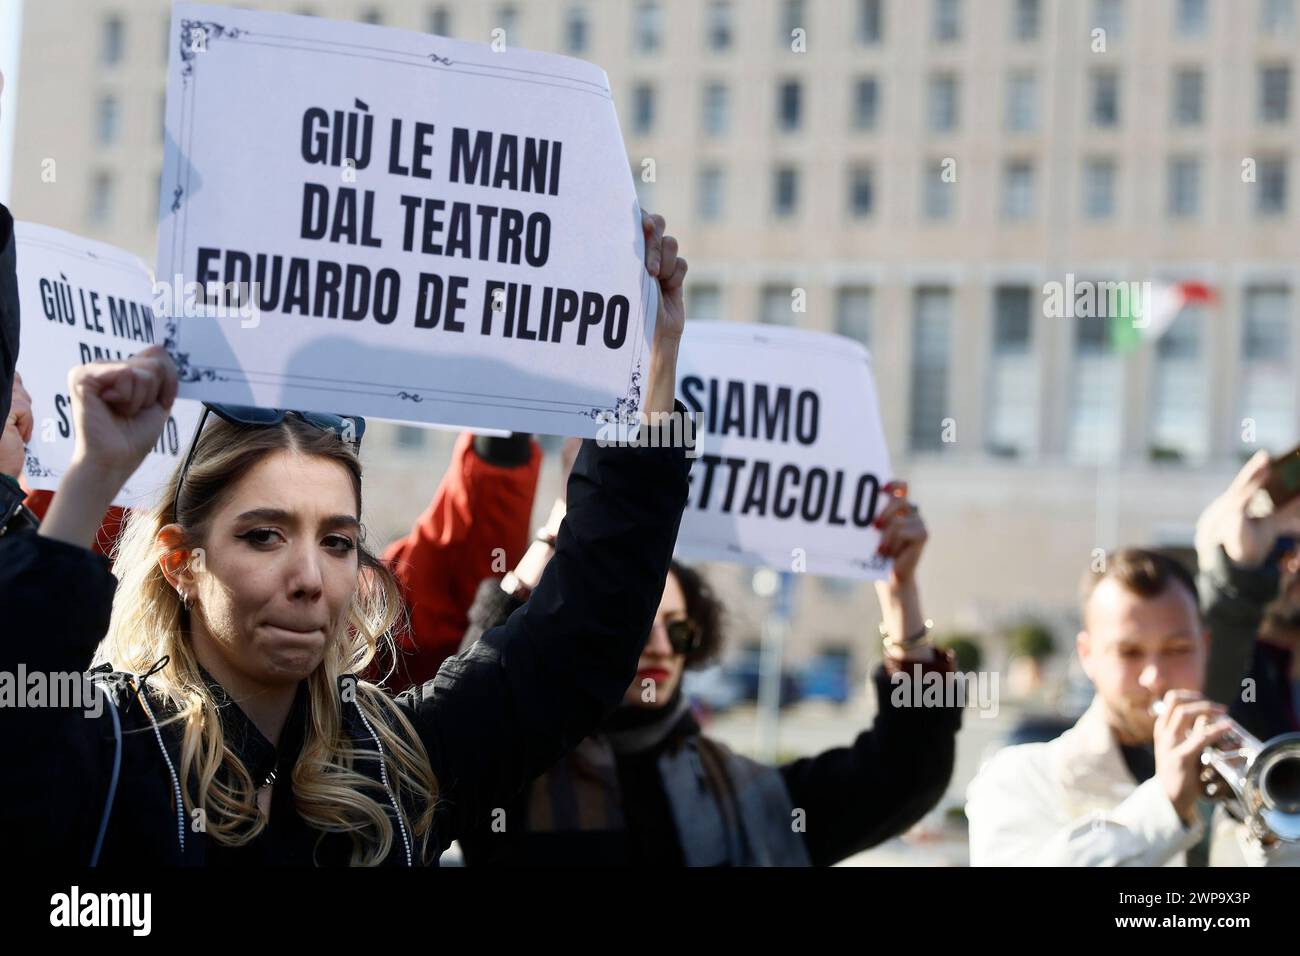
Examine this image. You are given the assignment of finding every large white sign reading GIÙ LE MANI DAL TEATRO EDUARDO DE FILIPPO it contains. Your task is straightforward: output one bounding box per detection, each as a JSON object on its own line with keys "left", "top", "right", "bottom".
{"left": 157, "top": 4, "right": 658, "bottom": 437}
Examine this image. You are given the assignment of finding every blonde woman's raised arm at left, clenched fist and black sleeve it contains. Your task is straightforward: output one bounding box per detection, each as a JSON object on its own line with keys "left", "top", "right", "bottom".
{"left": 0, "top": 349, "right": 176, "bottom": 864}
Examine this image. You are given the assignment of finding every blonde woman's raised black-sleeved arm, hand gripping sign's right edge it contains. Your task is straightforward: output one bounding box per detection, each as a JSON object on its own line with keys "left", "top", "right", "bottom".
{"left": 399, "top": 210, "right": 690, "bottom": 843}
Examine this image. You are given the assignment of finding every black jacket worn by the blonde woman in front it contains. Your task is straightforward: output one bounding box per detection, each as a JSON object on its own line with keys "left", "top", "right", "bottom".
{"left": 0, "top": 441, "right": 690, "bottom": 865}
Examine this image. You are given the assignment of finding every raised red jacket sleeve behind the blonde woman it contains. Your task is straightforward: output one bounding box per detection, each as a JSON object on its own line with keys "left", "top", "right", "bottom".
{"left": 384, "top": 432, "right": 542, "bottom": 691}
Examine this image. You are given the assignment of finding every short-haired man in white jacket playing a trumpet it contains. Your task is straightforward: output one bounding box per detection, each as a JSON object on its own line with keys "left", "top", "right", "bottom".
{"left": 966, "top": 455, "right": 1300, "bottom": 866}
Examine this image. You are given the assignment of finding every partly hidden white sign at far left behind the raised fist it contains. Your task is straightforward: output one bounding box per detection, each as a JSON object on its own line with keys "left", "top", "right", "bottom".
{"left": 14, "top": 222, "right": 202, "bottom": 507}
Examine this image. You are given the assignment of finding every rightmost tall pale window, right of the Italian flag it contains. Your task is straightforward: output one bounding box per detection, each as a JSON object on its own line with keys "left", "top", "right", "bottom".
{"left": 1239, "top": 286, "right": 1295, "bottom": 450}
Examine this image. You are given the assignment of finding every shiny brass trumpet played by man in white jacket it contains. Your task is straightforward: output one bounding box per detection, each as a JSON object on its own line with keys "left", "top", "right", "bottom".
{"left": 1151, "top": 700, "right": 1300, "bottom": 843}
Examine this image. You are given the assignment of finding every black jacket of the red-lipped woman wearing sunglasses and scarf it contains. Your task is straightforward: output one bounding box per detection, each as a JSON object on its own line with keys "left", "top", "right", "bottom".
{"left": 460, "top": 579, "right": 962, "bottom": 866}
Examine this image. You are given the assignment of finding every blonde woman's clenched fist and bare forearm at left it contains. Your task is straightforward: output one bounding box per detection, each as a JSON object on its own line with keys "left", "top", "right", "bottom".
{"left": 40, "top": 346, "right": 178, "bottom": 548}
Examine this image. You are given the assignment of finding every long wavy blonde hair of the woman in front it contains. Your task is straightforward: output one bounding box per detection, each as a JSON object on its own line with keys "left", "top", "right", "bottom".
{"left": 96, "top": 415, "right": 437, "bottom": 865}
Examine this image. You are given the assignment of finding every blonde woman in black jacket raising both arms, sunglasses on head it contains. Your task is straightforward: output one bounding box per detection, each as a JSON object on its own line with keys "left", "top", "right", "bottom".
{"left": 0, "top": 216, "right": 689, "bottom": 865}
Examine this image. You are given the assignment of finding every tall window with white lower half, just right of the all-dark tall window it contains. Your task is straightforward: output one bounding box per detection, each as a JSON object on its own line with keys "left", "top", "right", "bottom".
{"left": 985, "top": 286, "right": 1039, "bottom": 458}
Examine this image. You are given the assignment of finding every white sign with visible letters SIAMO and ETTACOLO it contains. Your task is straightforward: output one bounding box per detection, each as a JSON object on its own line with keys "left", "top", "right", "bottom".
{"left": 677, "top": 321, "right": 891, "bottom": 579}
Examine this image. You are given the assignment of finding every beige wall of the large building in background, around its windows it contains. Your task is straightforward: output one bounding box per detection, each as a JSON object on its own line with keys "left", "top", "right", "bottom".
{"left": 13, "top": 0, "right": 1300, "bottom": 686}
